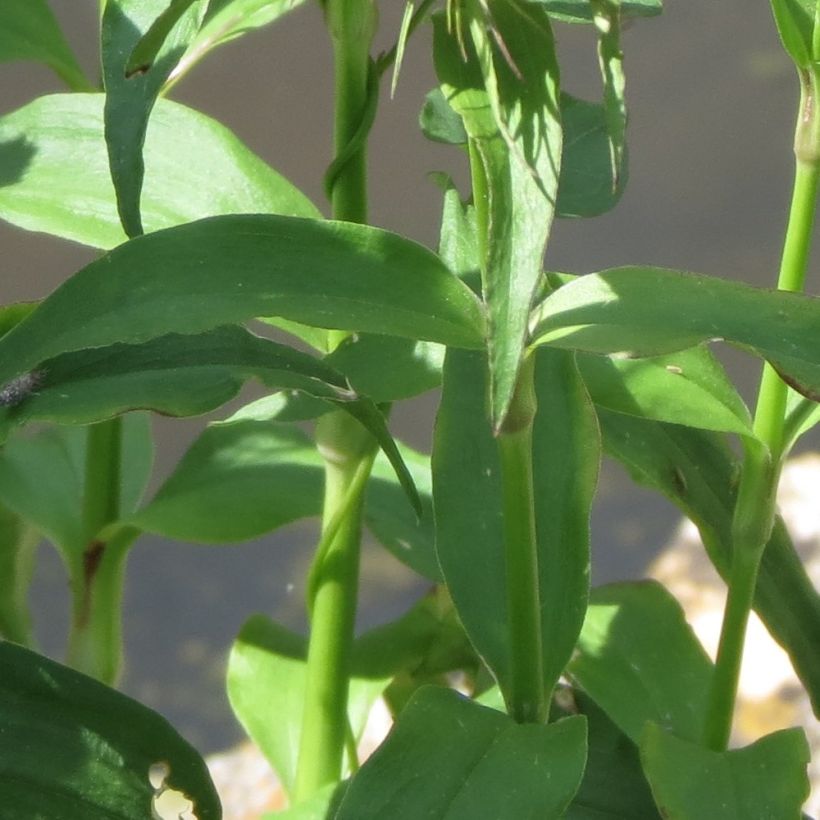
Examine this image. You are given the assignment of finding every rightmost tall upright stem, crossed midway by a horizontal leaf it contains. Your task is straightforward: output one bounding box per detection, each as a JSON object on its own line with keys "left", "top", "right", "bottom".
{"left": 704, "top": 71, "right": 820, "bottom": 751}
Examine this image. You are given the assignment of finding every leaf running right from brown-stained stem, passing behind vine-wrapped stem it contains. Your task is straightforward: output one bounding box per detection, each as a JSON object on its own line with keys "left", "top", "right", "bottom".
{"left": 127, "top": 419, "right": 439, "bottom": 580}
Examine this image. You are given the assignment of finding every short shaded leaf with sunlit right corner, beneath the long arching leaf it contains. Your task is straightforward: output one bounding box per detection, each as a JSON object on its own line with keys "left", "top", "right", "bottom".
{"left": 323, "top": 333, "right": 444, "bottom": 403}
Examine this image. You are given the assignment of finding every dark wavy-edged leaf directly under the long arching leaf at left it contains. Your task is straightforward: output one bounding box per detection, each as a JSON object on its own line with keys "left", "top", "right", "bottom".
{"left": 0, "top": 325, "right": 358, "bottom": 436}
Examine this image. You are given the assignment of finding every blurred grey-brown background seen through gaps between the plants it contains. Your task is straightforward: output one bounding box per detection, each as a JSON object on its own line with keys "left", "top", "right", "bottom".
{"left": 0, "top": 0, "right": 816, "bottom": 752}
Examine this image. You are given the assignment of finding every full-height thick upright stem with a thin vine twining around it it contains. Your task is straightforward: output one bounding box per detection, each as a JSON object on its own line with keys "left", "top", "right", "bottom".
{"left": 293, "top": 0, "right": 376, "bottom": 803}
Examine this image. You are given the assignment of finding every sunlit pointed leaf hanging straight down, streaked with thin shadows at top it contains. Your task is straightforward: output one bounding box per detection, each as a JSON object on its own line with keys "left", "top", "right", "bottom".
{"left": 434, "top": 0, "right": 561, "bottom": 428}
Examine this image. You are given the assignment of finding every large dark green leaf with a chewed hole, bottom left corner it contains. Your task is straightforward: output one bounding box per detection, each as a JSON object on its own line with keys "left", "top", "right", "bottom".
{"left": 0, "top": 643, "right": 222, "bottom": 820}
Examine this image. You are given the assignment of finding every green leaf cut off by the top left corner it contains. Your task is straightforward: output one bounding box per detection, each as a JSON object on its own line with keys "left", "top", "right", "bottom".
{"left": 0, "top": 0, "right": 91, "bottom": 91}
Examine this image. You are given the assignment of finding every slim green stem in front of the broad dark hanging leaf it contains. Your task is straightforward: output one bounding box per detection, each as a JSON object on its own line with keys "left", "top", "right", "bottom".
{"left": 498, "top": 356, "right": 547, "bottom": 723}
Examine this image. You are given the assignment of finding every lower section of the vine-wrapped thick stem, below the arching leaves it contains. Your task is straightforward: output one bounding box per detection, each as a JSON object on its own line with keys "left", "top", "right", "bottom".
{"left": 293, "top": 413, "right": 375, "bottom": 803}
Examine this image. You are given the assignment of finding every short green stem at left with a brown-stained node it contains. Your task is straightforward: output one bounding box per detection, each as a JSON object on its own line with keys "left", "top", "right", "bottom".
{"left": 67, "top": 418, "right": 124, "bottom": 684}
